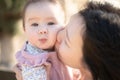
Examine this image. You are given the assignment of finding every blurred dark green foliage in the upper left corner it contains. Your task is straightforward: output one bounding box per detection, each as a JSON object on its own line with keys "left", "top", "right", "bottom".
{"left": 0, "top": 0, "right": 26, "bottom": 35}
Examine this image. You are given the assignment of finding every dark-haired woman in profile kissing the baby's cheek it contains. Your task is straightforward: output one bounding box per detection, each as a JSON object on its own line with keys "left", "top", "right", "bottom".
{"left": 13, "top": 2, "right": 120, "bottom": 80}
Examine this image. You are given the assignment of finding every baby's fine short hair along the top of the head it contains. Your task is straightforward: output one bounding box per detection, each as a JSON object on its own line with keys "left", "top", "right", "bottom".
{"left": 22, "top": 0, "right": 66, "bottom": 28}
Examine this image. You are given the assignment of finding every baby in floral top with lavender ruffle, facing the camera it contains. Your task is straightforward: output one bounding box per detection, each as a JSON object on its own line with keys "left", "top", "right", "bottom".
{"left": 16, "top": 0, "right": 65, "bottom": 80}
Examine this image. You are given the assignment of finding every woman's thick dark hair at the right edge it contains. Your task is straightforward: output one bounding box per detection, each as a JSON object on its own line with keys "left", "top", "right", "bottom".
{"left": 79, "top": 2, "right": 120, "bottom": 80}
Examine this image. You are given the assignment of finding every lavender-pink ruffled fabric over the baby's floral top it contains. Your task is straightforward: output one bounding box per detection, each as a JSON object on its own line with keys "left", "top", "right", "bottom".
{"left": 16, "top": 44, "right": 80, "bottom": 80}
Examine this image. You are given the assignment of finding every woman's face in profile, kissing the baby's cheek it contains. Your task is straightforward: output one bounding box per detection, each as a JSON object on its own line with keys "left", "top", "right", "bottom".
{"left": 56, "top": 14, "right": 84, "bottom": 68}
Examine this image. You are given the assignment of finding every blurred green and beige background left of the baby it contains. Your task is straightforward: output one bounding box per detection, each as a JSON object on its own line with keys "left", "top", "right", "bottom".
{"left": 0, "top": 0, "right": 26, "bottom": 80}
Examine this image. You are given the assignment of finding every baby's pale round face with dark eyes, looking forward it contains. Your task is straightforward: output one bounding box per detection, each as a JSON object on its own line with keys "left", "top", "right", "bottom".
{"left": 25, "top": 2, "right": 64, "bottom": 49}
